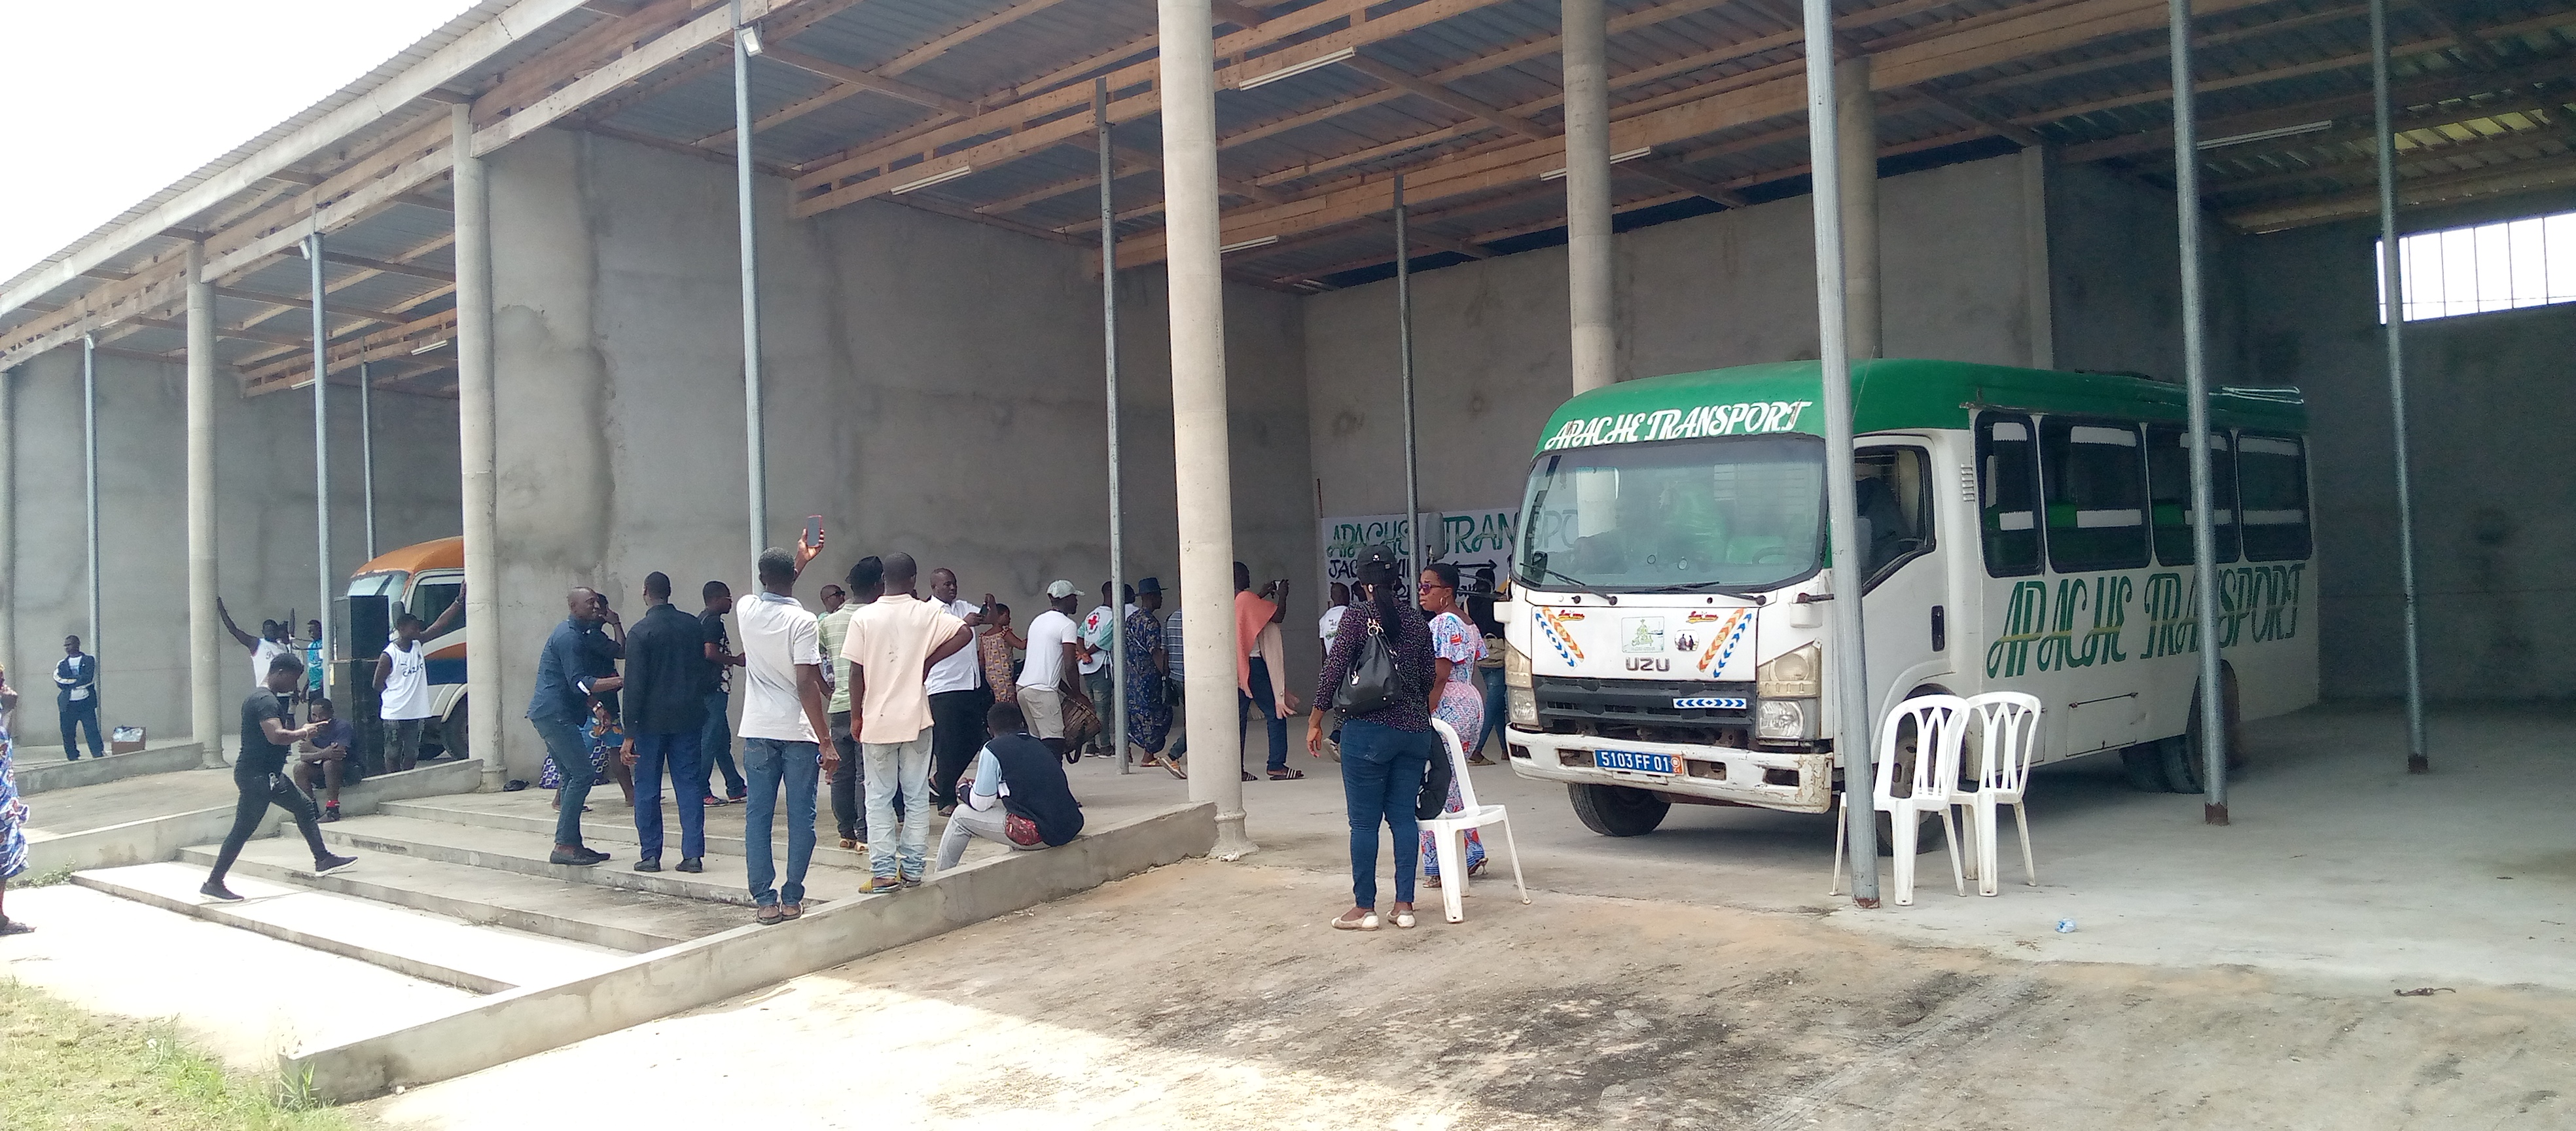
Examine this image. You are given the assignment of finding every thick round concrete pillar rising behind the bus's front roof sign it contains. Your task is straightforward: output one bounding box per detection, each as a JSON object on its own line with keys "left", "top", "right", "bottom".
{"left": 1561, "top": 0, "right": 1618, "bottom": 391}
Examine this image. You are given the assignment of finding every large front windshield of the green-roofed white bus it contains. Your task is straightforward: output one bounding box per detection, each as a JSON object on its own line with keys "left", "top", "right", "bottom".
{"left": 1514, "top": 435, "right": 1824, "bottom": 592}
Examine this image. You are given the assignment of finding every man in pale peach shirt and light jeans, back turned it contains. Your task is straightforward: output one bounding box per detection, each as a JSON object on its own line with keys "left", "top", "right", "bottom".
{"left": 842, "top": 554, "right": 974, "bottom": 891}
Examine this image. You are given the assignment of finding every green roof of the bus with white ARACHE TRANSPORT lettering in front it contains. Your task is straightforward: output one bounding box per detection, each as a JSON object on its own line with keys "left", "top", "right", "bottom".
{"left": 1538, "top": 358, "right": 2308, "bottom": 451}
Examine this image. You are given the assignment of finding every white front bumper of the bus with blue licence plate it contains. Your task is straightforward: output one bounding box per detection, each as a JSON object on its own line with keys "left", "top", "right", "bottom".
{"left": 1505, "top": 729, "right": 1834, "bottom": 814}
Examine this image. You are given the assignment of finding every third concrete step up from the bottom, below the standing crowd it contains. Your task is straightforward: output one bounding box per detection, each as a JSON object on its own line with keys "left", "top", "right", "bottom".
{"left": 304, "top": 817, "right": 868, "bottom": 907}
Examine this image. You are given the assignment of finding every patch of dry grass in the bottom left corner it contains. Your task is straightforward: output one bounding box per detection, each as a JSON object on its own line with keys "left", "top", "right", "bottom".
{"left": 0, "top": 979, "right": 350, "bottom": 1131}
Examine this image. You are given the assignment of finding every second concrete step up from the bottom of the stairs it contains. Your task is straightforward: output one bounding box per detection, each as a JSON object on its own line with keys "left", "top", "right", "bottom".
{"left": 178, "top": 822, "right": 747, "bottom": 953}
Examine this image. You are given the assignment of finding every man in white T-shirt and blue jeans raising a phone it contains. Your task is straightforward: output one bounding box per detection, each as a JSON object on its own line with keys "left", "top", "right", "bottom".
{"left": 734, "top": 546, "right": 840, "bottom": 925}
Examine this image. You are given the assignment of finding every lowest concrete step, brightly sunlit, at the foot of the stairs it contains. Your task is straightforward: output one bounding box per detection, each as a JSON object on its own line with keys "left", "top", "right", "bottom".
{"left": 72, "top": 863, "right": 626, "bottom": 994}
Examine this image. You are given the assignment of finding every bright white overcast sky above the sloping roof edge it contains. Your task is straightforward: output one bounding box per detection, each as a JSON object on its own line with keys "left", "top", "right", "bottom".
{"left": 0, "top": 0, "right": 474, "bottom": 278}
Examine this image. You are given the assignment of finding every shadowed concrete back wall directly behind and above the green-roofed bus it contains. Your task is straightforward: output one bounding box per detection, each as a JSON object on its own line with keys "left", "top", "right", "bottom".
{"left": 1293, "top": 154, "right": 2037, "bottom": 577}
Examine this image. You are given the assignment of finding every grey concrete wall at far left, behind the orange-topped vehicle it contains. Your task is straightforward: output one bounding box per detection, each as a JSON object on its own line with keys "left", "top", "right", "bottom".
{"left": 0, "top": 355, "right": 459, "bottom": 745}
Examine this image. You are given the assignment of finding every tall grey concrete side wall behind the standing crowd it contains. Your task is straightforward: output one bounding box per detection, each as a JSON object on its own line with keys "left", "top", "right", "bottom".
{"left": 492, "top": 132, "right": 1314, "bottom": 778}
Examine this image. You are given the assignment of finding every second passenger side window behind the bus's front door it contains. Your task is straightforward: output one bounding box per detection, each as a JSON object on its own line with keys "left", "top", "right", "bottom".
{"left": 2040, "top": 418, "right": 2146, "bottom": 575}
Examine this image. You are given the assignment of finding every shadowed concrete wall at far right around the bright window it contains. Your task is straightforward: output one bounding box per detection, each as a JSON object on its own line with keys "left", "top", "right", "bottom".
{"left": 2241, "top": 193, "right": 2576, "bottom": 698}
